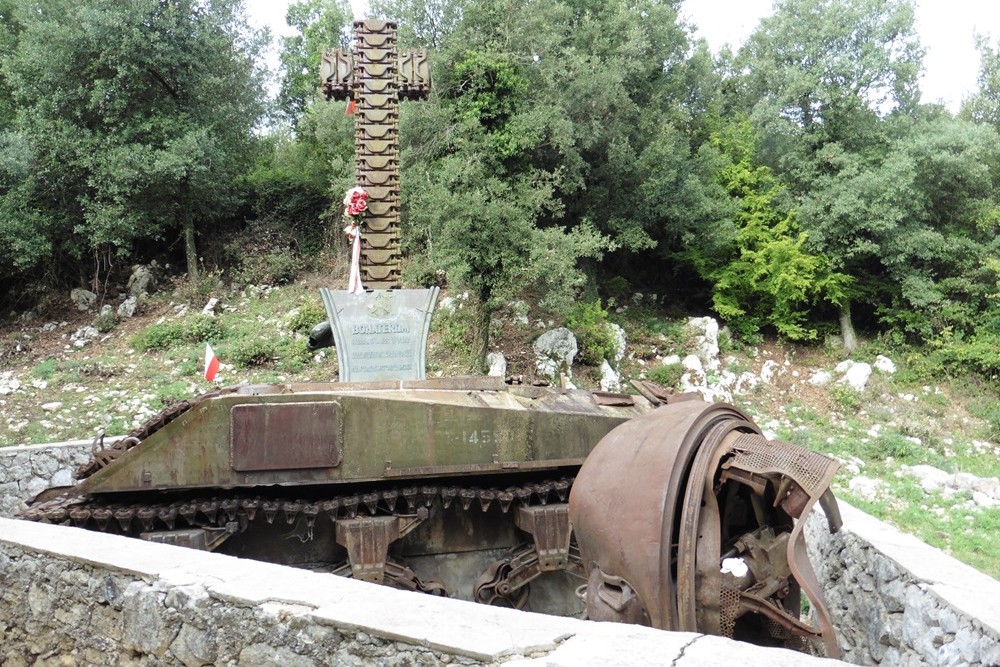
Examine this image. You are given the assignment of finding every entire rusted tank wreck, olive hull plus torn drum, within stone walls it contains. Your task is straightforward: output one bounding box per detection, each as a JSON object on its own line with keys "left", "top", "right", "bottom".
{"left": 21, "top": 378, "right": 836, "bottom": 653}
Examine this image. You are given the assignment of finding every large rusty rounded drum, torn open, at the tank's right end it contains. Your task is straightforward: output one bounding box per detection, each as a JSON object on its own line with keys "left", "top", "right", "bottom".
{"left": 569, "top": 401, "right": 840, "bottom": 658}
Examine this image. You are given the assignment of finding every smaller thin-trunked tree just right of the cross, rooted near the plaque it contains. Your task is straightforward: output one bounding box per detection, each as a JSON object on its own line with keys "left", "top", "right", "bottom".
{"left": 402, "top": 44, "right": 605, "bottom": 364}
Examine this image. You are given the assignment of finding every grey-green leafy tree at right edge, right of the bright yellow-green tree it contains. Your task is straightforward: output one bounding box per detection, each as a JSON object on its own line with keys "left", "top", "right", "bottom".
{"left": 801, "top": 114, "right": 1000, "bottom": 341}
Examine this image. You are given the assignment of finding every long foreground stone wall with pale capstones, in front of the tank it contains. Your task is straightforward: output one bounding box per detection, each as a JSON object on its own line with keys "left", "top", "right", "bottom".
{"left": 0, "top": 519, "right": 842, "bottom": 667}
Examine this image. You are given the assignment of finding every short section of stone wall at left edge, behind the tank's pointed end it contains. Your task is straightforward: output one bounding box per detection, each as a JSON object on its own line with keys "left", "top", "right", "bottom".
{"left": 0, "top": 440, "right": 91, "bottom": 517}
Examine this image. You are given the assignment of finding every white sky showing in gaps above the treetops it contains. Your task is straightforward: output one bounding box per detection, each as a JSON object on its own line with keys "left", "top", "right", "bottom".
{"left": 247, "top": 0, "right": 1000, "bottom": 112}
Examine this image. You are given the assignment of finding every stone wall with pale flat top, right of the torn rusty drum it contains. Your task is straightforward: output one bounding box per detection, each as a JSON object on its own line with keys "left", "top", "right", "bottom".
{"left": 806, "top": 502, "right": 1000, "bottom": 667}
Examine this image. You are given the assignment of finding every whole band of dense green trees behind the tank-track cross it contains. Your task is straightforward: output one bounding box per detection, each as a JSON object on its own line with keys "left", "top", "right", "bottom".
{"left": 0, "top": 0, "right": 1000, "bottom": 376}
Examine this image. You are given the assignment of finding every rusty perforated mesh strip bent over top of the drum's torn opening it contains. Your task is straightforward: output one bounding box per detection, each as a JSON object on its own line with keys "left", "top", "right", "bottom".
{"left": 730, "top": 433, "right": 838, "bottom": 496}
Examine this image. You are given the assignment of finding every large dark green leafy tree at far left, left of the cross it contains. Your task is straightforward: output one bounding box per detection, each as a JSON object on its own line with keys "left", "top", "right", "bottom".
{"left": 0, "top": 0, "right": 264, "bottom": 290}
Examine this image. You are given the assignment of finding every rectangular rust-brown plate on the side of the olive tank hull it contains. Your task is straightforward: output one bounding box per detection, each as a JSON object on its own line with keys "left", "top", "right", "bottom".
{"left": 230, "top": 402, "right": 340, "bottom": 472}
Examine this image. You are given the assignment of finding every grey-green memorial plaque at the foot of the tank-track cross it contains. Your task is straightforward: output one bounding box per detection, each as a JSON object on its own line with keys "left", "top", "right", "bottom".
{"left": 320, "top": 287, "right": 440, "bottom": 382}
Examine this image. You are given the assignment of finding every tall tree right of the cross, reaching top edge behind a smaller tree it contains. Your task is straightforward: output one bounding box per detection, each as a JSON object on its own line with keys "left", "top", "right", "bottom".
{"left": 398, "top": 0, "right": 726, "bottom": 328}
